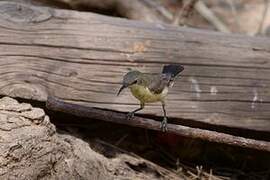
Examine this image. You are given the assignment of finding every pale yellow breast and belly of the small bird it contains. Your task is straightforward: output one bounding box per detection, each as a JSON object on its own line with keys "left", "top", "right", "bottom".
{"left": 129, "top": 84, "right": 168, "bottom": 103}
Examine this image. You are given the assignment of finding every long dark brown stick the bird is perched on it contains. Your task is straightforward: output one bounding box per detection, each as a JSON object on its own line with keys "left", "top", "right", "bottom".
{"left": 46, "top": 96, "right": 270, "bottom": 152}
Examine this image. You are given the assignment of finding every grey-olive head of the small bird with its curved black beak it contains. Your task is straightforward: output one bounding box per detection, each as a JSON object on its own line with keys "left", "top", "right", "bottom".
{"left": 117, "top": 71, "right": 141, "bottom": 96}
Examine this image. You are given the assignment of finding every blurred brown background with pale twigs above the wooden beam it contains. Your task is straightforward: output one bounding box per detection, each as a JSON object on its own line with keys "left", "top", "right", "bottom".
{"left": 13, "top": 0, "right": 270, "bottom": 36}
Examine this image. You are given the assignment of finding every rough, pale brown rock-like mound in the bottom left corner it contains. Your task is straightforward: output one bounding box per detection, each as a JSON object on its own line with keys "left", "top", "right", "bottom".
{"left": 0, "top": 97, "right": 111, "bottom": 179}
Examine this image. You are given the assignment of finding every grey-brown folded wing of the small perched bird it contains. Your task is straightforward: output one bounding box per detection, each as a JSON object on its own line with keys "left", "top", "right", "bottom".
{"left": 147, "top": 74, "right": 170, "bottom": 94}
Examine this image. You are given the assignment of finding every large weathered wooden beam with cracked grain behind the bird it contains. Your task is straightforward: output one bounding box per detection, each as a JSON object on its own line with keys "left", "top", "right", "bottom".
{"left": 0, "top": 1, "right": 270, "bottom": 132}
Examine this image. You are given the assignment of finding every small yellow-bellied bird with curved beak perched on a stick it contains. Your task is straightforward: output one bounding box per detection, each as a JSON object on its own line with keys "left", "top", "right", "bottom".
{"left": 117, "top": 64, "right": 184, "bottom": 132}
